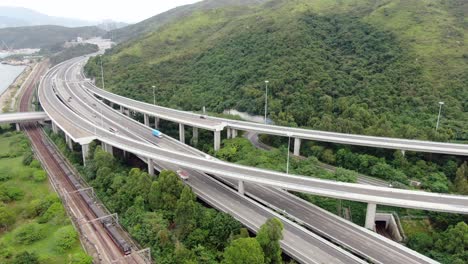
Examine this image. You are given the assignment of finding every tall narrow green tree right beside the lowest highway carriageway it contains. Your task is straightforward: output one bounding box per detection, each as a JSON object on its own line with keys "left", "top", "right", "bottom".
{"left": 256, "top": 218, "right": 283, "bottom": 264}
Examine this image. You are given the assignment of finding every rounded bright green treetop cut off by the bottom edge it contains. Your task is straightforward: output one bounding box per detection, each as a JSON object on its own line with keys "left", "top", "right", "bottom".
{"left": 222, "top": 238, "right": 264, "bottom": 264}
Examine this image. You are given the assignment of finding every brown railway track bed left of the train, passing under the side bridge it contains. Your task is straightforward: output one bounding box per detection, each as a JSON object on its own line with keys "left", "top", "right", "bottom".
{"left": 19, "top": 60, "right": 144, "bottom": 264}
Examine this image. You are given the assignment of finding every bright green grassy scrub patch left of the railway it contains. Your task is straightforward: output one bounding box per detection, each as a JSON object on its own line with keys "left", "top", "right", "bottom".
{"left": 0, "top": 132, "right": 90, "bottom": 264}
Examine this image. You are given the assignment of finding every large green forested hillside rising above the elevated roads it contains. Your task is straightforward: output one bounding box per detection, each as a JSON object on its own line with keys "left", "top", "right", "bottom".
{"left": 86, "top": 0, "right": 468, "bottom": 140}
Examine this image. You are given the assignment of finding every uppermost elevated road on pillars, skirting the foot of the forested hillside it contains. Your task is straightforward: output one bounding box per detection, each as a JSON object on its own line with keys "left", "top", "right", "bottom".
{"left": 83, "top": 81, "right": 468, "bottom": 156}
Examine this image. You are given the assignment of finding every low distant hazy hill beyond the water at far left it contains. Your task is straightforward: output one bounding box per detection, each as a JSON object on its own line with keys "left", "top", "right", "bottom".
{"left": 0, "top": 26, "right": 105, "bottom": 49}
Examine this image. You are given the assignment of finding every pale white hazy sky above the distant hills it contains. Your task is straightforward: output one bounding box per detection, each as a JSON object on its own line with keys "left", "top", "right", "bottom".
{"left": 0, "top": 0, "right": 199, "bottom": 23}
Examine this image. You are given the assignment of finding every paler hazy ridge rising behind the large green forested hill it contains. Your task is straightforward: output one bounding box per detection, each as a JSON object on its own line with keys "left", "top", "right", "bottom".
{"left": 106, "top": 0, "right": 267, "bottom": 42}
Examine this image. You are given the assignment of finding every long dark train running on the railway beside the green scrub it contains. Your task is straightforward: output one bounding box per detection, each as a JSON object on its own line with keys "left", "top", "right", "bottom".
{"left": 44, "top": 138, "right": 132, "bottom": 255}
